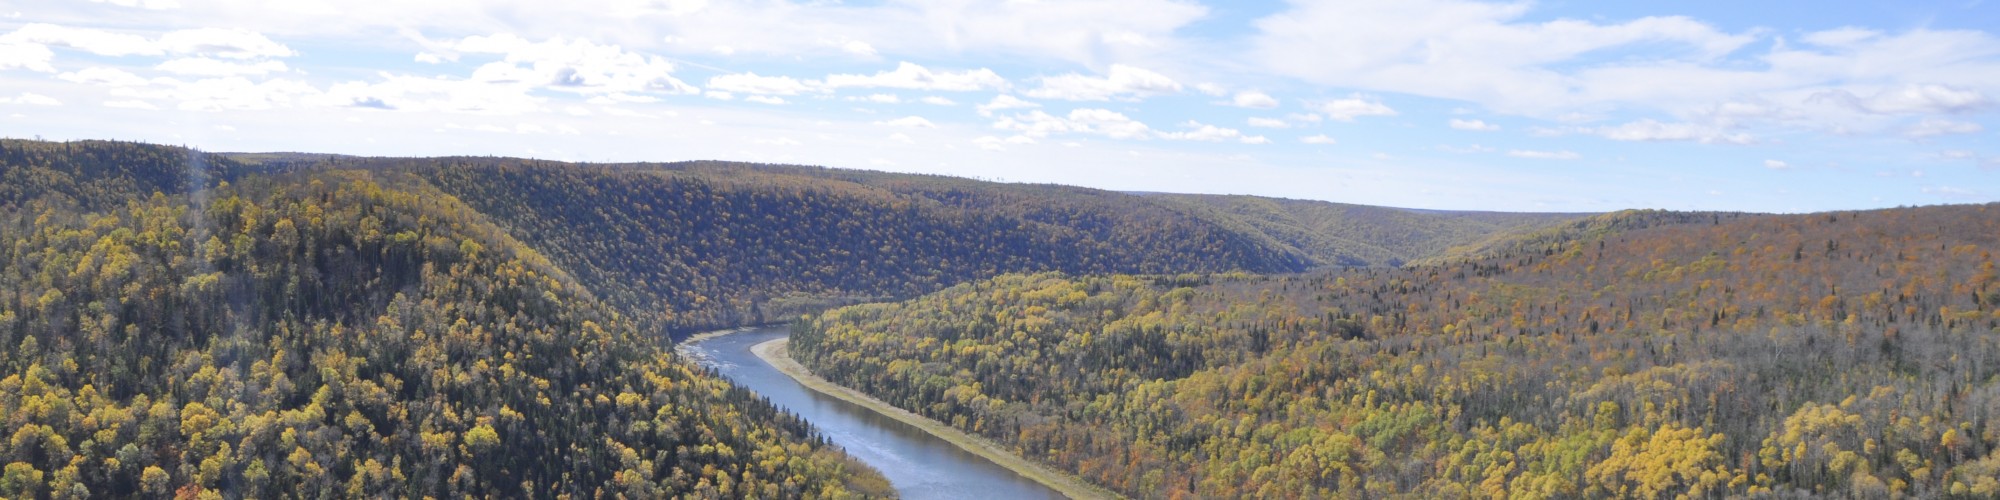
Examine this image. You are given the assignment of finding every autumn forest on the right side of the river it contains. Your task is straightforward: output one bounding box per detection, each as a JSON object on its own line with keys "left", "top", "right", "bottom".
{"left": 792, "top": 204, "right": 2000, "bottom": 498}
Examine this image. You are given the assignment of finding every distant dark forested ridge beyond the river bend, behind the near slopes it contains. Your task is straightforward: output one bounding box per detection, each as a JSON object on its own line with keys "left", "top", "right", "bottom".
{"left": 219, "top": 154, "right": 1566, "bottom": 334}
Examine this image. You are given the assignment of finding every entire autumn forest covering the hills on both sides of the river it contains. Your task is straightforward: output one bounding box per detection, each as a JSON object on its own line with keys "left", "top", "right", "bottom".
{"left": 15, "top": 140, "right": 2000, "bottom": 498}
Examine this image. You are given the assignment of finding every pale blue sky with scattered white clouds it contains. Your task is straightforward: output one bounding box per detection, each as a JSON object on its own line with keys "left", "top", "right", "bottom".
{"left": 0, "top": 0, "right": 2000, "bottom": 212}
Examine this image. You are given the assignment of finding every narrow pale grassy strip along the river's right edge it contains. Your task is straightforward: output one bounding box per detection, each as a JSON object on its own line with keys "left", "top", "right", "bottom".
{"left": 750, "top": 338, "right": 1122, "bottom": 498}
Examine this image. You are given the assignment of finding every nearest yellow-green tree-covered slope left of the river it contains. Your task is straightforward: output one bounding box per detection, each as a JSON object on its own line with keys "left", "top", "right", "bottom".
{"left": 0, "top": 142, "right": 888, "bottom": 498}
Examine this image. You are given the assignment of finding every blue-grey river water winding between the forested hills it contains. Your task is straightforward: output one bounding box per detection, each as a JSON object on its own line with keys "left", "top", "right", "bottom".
{"left": 680, "top": 326, "right": 1062, "bottom": 498}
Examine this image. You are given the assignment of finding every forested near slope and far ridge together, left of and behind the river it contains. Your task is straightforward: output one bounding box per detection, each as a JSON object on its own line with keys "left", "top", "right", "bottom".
{"left": 0, "top": 140, "right": 1574, "bottom": 498}
